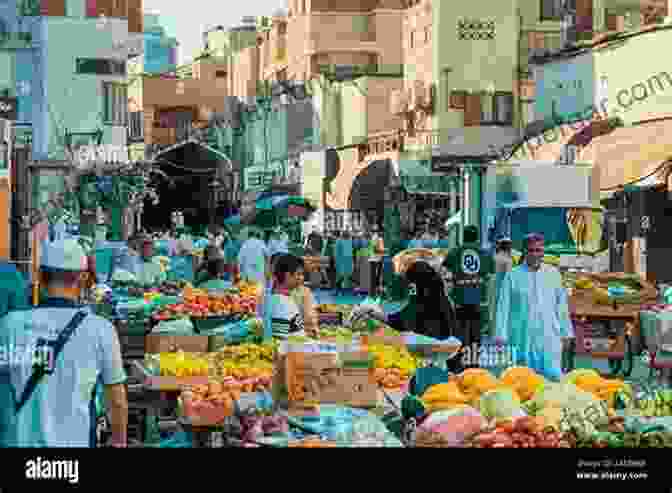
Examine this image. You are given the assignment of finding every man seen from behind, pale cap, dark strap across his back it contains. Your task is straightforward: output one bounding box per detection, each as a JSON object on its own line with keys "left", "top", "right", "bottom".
{"left": 0, "top": 238, "right": 128, "bottom": 447}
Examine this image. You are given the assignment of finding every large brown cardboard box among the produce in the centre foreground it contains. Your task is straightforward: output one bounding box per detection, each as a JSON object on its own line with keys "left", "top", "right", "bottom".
{"left": 274, "top": 351, "right": 378, "bottom": 409}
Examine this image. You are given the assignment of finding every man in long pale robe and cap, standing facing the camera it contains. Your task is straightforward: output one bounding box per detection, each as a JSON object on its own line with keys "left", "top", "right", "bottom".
{"left": 495, "top": 234, "right": 574, "bottom": 380}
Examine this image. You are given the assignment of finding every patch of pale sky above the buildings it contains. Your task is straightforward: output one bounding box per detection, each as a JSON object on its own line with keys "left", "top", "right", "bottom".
{"left": 143, "top": 0, "right": 287, "bottom": 64}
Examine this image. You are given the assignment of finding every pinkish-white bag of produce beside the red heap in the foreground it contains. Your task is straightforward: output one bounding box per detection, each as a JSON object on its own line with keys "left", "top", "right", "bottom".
{"left": 418, "top": 406, "right": 487, "bottom": 447}
